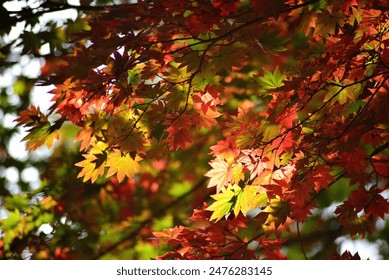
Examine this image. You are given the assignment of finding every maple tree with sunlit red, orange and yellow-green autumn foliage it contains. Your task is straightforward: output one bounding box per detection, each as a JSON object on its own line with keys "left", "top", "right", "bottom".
{"left": 0, "top": 0, "right": 389, "bottom": 259}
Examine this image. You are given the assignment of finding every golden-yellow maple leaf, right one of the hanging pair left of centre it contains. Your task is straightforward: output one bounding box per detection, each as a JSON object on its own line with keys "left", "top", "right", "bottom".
{"left": 105, "top": 149, "right": 142, "bottom": 183}
